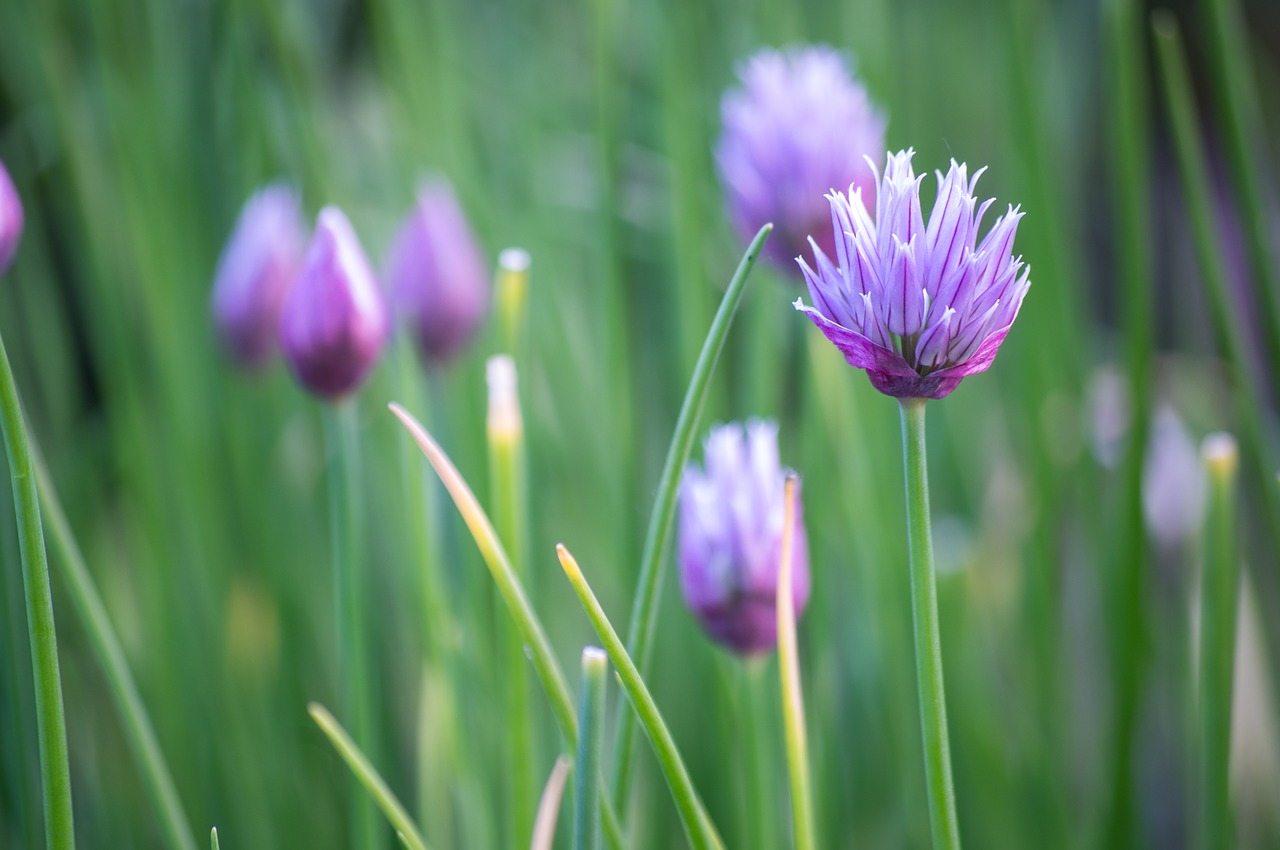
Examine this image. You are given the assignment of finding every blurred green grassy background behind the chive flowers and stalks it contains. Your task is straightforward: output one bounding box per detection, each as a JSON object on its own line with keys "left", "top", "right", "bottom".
{"left": 0, "top": 0, "right": 1280, "bottom": 850}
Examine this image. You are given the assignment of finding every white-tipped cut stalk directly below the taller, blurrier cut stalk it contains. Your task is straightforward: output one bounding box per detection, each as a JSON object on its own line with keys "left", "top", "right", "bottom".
{"left": 486, "top": 355, "right": 535, "bottom": 840}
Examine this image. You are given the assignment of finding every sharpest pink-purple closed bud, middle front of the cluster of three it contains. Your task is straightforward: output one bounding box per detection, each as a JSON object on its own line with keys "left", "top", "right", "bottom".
{"left": 280, "top": 206, "right": 387, "bottom": 399}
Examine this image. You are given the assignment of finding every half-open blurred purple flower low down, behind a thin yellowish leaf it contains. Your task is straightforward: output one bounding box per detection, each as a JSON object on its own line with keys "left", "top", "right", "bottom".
{"left": 680, "top": 421, "right": 809, "bottom": 655}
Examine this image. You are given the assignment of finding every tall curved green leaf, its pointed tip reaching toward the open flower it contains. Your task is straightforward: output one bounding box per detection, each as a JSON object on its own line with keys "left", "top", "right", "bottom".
{"left": 612, "top": 224, "right": 773, "bottom": 819}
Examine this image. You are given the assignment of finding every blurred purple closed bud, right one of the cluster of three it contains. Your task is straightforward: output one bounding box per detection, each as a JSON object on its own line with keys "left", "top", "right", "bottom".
{"left": 387, "top": 180, "right": 489, "bottom": 361}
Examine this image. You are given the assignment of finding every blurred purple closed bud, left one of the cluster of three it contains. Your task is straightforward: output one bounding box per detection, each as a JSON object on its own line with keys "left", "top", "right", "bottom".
{"left": 212, "top": 183, "right": 307, "bottom": 369}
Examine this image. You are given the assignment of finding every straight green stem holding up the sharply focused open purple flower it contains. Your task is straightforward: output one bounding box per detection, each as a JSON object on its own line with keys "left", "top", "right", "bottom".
{"left": 900, "top": 398, "right": 960, "bottom": 850}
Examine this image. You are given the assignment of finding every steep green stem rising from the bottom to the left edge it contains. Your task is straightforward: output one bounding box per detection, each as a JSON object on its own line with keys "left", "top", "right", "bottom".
{"left": 0, "top": 330, "right": 76, "bottom": 850}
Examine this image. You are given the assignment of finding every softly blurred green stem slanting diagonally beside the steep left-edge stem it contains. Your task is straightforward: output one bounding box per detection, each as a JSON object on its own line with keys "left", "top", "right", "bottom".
{"left": 31, "top": 444, "right": 196, "bottom": 850}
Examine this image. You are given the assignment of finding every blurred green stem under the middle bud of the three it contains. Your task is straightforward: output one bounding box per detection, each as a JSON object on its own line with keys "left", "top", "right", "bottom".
{"left": 324, "top": 401, "right": 381, "bottom": 850}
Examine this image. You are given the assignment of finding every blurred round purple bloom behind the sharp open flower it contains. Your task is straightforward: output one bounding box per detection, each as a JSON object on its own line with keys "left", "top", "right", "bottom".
{"left": 716, "top": 46, "right": 884, "bottom": 274}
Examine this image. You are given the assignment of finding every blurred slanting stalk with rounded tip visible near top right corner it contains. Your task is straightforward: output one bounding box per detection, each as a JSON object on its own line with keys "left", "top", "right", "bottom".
{"left": 1151, "top": 12, "right": 1280, "bottom": 545}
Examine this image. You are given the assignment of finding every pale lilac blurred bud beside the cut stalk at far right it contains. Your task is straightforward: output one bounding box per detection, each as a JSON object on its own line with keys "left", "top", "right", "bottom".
{"left": 1142, "top": 406, "right": 1206, "bottom": 548}
